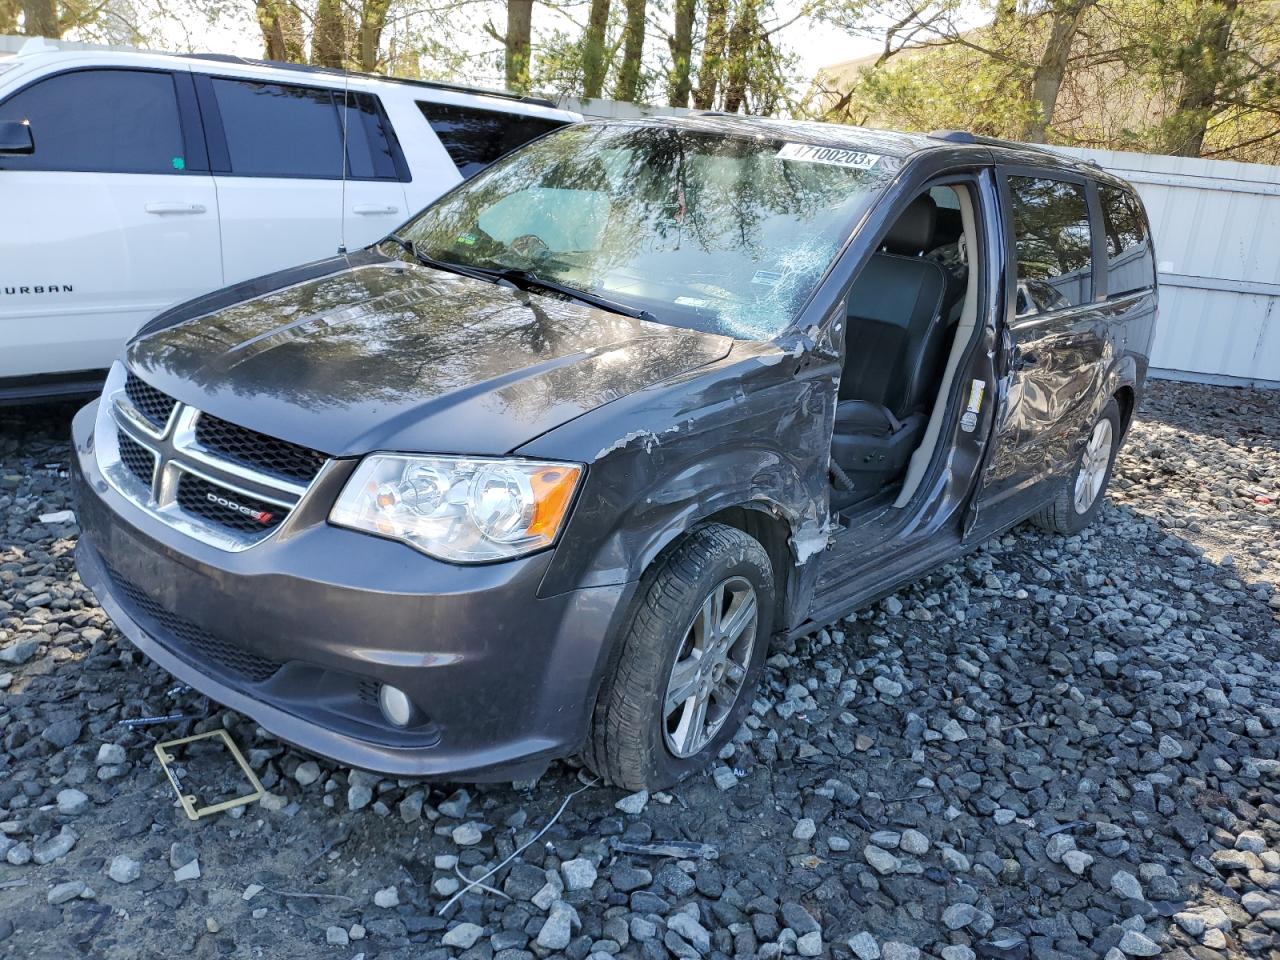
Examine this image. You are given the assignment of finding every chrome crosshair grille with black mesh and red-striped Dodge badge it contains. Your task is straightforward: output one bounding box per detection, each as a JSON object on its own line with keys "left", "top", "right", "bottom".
{"left": 95, "top": 365, "right": 328, "bottom": 550}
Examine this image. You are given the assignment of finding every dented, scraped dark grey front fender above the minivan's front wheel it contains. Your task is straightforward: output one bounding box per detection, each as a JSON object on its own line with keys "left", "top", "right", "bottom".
{"left": 518, "top": 337, "right": 838, "bottom": 624}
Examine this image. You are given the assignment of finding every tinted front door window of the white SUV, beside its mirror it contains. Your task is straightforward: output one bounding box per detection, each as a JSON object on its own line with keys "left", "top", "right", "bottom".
{"left": 0, "top": 70, "right": 187, "bottom": 173}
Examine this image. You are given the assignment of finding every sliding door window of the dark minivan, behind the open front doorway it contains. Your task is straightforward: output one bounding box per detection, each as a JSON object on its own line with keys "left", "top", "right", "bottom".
{"left": 1009, "top": 177, "right": 1093, "bottom": 316}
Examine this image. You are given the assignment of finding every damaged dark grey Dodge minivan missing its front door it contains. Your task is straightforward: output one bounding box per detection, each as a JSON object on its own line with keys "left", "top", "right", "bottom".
{"left": 74, "top": 116, "right": 1157, "bottom": 788}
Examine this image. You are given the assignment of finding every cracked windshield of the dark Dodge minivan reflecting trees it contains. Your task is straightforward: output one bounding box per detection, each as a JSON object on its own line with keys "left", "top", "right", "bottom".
{"left": 403, "top": 124, "right": 891, "bottom": 339}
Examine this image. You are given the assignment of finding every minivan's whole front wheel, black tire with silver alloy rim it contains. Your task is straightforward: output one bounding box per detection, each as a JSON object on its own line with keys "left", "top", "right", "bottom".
{"left": 582, "top": 524, "right": 774, "bottom": 790}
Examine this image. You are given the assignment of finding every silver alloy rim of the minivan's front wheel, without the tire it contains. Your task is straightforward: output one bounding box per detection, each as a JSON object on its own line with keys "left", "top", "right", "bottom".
{"left": 662, "top": 577, "right": 759, "bottom": 758}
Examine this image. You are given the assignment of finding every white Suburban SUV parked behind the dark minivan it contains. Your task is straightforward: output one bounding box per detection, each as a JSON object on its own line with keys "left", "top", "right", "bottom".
{"left": 0, "top": 50, "right": 581, "bottom": 401}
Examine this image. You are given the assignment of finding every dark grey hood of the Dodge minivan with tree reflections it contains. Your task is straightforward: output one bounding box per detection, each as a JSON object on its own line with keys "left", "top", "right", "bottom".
{"left": 127, "top": 260, "right": 732, "bottom": 456}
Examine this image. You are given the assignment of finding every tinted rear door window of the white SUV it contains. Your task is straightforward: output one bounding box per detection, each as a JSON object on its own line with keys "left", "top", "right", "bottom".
{"left": 211, "top": 77, "right": 397, "bottom": 180}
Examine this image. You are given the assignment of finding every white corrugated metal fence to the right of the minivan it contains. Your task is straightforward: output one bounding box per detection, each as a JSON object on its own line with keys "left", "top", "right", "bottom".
{"left": 1055, "top": 147, "right": 1280, "bottom": 387}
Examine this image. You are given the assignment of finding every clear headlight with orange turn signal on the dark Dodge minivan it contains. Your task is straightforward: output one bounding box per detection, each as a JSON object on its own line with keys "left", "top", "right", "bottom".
{"left": 329, "top": 453, "right": 582, "bottom": 563}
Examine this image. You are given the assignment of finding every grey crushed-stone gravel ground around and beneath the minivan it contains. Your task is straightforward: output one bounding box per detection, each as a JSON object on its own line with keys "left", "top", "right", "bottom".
{"left": 0, "top": 383, "right": 1280, "bottom": 960}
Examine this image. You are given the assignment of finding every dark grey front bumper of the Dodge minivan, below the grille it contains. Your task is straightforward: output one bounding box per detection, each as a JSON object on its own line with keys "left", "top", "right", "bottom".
{"left": 72, "top": 403, "right": 634, "bottom": 781}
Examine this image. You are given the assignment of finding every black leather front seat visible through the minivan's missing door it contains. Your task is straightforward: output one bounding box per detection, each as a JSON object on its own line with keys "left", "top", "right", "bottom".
{"left": 832, "top": 193, "right": 952, "bottom": 503}
